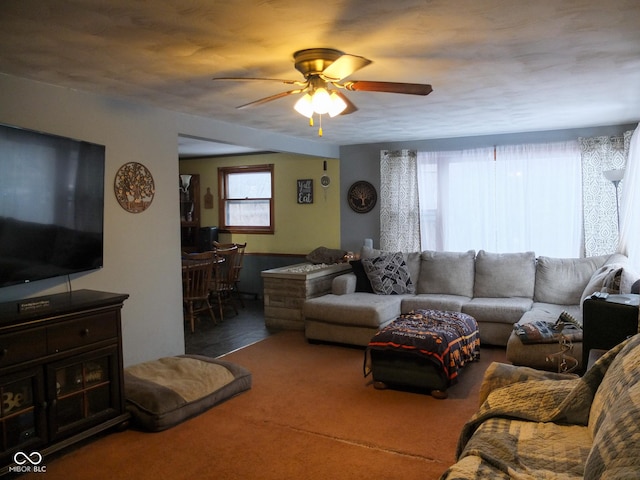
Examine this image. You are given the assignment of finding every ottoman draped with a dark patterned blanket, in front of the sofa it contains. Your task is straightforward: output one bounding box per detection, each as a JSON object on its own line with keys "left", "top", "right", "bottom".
{"left": 365, "top": 310, "right": 480, "bottom": 398}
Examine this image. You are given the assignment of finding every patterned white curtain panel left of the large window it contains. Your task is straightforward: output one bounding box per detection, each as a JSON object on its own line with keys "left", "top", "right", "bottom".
{"left": 380, "top": 150, "right": 420, "bottom": 252}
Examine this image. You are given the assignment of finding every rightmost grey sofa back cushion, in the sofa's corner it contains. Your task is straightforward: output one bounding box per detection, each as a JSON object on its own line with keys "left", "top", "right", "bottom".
{"left": 534, "top": 255, "right": 608, "bottom": 305}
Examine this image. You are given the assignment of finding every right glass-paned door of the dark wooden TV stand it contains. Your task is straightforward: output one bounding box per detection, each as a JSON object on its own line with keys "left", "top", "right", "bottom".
{"left": 50, "top": 348, "right": 118, "bottom": 437}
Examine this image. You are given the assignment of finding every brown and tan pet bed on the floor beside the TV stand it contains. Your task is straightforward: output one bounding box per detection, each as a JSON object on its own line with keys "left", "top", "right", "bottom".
{"left": 124, "top": 355, "right": 251, "bottom": 432}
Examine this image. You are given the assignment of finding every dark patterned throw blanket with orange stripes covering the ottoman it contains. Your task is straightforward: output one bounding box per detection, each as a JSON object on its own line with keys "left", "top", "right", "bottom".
{"left": 369, "top": 310, "right": 480, "bottom": 384}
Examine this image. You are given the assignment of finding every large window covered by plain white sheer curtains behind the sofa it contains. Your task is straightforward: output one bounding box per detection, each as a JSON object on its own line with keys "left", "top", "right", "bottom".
{"left": 418, "top": 142, "right": 582, "bottom": 257}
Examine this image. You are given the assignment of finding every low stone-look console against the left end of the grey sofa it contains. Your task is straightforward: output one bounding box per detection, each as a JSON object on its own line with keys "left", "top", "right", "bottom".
{"left": 262, "top": 263, "right": 351, "bottom": 330}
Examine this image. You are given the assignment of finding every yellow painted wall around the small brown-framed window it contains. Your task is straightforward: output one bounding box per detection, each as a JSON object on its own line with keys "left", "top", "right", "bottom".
{"left": 179, "top": 153, "right": 340, "bottom": 254}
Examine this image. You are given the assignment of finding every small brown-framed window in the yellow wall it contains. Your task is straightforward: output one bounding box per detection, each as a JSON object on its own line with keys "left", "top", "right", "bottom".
{"left": 218, "top": 164, "right": 274, "bottom": 233}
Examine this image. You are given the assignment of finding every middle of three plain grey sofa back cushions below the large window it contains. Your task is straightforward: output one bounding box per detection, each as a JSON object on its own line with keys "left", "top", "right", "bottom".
{"left": 473, "top": 250, "right": 536, "bottom": 303}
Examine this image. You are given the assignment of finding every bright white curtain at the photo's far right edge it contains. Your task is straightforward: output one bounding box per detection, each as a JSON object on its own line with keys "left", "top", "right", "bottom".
{"left": 619, "top": 126, "right": 640, "bottom": 269}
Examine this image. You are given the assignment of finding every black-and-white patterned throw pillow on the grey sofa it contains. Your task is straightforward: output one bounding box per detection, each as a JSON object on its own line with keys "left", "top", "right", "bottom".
{"left": 362, "top": 252, "right": 416, "bottom": 295}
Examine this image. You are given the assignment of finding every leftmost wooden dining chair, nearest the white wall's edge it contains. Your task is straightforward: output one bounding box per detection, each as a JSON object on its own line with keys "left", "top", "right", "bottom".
{"left": 182, "top": 251, "right": 218, "bottom": 333}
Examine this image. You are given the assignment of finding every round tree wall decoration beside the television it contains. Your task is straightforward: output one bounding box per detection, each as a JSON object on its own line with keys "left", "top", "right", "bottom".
{"left": 113, "top": 162, "right": 156, "bottom": 213}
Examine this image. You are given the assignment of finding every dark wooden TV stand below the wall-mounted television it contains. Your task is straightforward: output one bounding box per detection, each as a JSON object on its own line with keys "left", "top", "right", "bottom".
{"left": 0, "top": 290, "right": 129, "bottom": 476}
